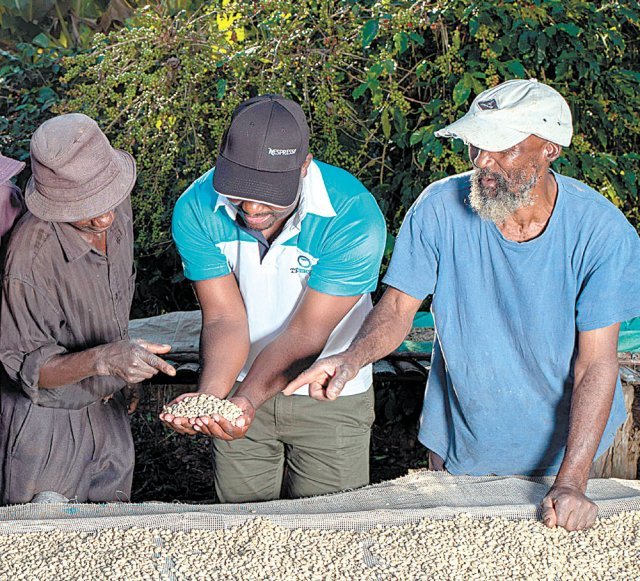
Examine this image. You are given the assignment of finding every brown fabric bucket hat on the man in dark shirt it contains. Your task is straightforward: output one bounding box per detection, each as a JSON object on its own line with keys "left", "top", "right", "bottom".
{"left": 25, "top": 113, "right": 136, "bottom": 222}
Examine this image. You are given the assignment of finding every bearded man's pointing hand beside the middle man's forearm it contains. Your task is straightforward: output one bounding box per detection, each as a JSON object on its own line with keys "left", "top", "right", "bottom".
{"left": 282, "top": 355, "right": 360, "bottom": 401}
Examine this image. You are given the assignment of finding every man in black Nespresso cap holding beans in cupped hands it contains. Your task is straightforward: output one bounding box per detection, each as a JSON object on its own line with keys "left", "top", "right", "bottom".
{"left": 161, "top": 95, "right": 386, "bottom": 502}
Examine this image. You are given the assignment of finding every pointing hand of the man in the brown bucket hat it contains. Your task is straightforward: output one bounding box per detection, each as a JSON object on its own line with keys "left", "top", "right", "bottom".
{"left": 98, "top": 339, "right": 176, "bottom": 383}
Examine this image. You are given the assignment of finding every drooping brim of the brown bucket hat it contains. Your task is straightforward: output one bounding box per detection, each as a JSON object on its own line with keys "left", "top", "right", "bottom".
{"left": 24, "top": 149, "right": 136, "bottom": 222}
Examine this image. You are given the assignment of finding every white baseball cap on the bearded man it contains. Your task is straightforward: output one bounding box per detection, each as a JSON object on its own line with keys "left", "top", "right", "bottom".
{"left": 436, "top": 79, "right": 573, "bottom": 151}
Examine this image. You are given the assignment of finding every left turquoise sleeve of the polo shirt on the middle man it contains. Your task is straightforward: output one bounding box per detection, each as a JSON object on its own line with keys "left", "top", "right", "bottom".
{"left": 171, "top": 172, "right": 231, "bottom": 281}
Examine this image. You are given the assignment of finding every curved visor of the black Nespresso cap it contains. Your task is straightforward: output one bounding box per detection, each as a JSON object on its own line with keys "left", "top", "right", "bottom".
{"left": 213, "top": 155, "right": 300, "bottom": 208}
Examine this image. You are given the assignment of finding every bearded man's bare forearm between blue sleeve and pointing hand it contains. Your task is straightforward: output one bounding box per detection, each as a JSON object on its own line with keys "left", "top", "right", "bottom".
{"left": 344, "top": 288, "right": 421, "bottom": 367}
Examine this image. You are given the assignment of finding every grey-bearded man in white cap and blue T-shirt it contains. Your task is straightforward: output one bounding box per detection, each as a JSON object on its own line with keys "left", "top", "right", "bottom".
{"left": 289, "top": 79, "right": 640, "bottom": 530}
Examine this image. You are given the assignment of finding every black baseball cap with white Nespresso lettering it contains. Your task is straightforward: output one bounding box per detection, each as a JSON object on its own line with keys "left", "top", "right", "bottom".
{"left": 213, "top": 95, "right": 309, "bottom": 208}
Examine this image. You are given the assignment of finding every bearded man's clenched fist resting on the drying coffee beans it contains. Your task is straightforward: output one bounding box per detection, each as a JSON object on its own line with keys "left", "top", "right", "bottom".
{"left": 541, "top": 484, "right": 598, "bottom": 531}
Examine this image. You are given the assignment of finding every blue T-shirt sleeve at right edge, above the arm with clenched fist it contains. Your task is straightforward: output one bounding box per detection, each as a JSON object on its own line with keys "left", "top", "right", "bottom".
{"left": 576, "top": 216, "right": 640, "bottom": 331}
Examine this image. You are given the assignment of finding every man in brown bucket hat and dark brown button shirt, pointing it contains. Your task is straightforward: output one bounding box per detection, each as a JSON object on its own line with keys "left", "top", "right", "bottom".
{"left": 0, "top": 114, "right": 175, "bottom": 504}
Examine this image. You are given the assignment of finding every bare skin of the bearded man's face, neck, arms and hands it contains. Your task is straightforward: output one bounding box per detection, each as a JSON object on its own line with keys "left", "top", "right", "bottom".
{"left": 284, "top": 136, "right": 619, "bottom": 531}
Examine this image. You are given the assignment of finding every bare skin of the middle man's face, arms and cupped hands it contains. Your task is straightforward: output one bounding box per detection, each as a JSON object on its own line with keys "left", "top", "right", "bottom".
{"left": 160, "top": 155, "right": 360, "bottom": 441}
